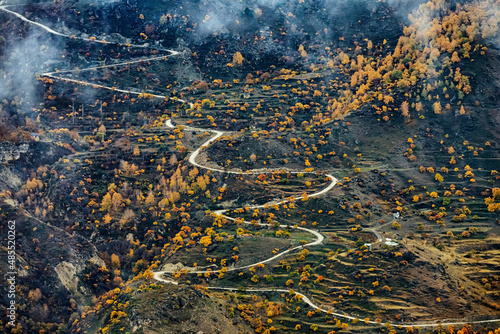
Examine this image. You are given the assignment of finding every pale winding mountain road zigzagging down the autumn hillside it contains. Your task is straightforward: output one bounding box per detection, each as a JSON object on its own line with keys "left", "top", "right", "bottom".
{"left": 0, "top": 6, "right": 500, "bottom": 328}
